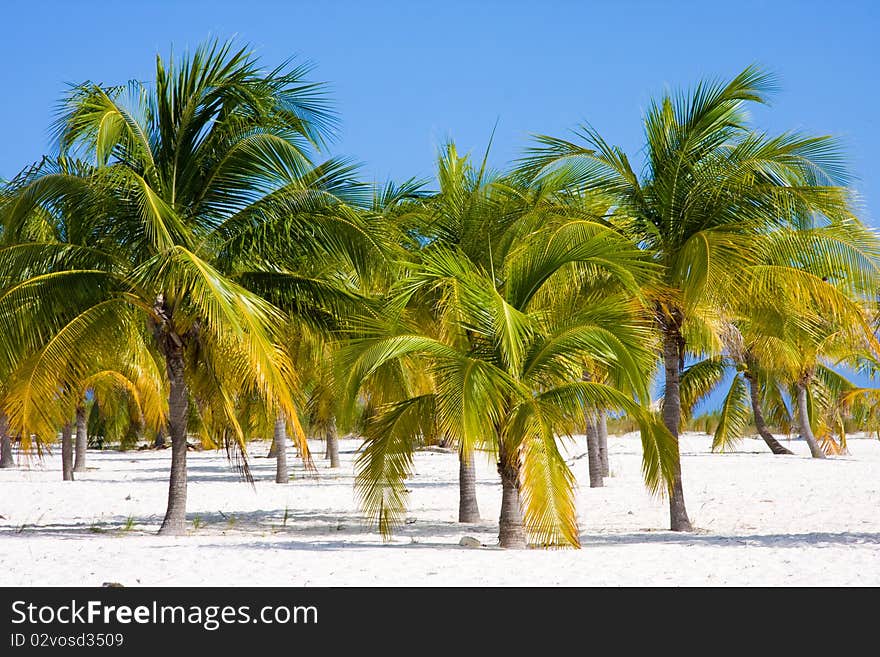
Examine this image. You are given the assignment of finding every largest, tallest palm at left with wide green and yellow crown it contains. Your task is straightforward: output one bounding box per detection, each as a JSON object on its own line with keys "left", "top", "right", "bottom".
{"left": 0, "top": 42, "right": 372, "bottom": 534}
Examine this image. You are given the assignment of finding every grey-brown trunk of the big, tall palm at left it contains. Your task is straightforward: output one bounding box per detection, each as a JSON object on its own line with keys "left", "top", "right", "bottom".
{"left": 159, "top": 336, "right": 189, "bottom": 536}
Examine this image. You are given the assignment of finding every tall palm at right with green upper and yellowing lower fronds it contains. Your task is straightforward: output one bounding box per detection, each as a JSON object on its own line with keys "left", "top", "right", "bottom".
{"left": 522, "top": 67, "right": 850, "bottom": 531}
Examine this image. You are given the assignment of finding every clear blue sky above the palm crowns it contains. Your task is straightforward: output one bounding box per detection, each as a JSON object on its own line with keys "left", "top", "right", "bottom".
{"left": 0, "top": 0, "right": 880, "bottom": 410}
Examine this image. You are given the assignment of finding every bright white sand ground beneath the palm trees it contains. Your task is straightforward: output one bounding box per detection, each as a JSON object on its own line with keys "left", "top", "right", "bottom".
{"left": 0, "top": 435, "right": 880, "bottom": 586}
